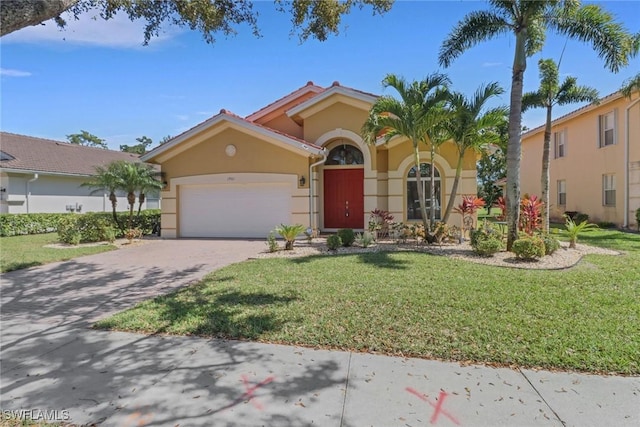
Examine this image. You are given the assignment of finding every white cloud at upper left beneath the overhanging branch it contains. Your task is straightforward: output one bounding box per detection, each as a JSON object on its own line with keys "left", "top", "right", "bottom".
{"left": 2, "top": 12, "right": 177, "bottom": 49}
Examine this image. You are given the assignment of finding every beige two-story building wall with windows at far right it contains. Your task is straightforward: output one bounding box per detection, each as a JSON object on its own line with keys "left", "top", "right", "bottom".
{"left": 521, "top": 95, "right": 640, "bottom": 226}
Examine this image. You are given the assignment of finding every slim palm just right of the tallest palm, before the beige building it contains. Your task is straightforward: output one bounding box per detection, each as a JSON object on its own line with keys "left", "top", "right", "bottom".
{"left": 522, "top": 59, "right": 598, "bottom": 232}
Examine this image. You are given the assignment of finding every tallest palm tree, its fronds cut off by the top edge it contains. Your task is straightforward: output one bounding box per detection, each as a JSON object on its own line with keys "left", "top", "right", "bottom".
{"left": 438, "top": 0, "right": 640, "bottom": 250}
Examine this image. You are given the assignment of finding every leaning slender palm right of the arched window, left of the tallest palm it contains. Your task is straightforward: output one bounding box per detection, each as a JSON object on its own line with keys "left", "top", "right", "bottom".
{"left": 442, "top": 82, "right": 507, "bottom": 222}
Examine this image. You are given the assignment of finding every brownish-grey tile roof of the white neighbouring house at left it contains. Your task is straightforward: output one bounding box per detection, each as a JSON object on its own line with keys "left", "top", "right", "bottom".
{"left": 0, "top": 132, "right": 140, "bottom": 176}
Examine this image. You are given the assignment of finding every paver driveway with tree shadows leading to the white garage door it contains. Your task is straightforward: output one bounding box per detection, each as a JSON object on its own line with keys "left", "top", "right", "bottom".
{"left": 0, "top": 239, "right": 265, "bottom": 329}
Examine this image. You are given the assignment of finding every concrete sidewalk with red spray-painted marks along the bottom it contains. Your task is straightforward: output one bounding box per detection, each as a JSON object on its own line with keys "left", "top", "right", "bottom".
{"left": 0, "top": 319, "right": 640, "bottom": 426}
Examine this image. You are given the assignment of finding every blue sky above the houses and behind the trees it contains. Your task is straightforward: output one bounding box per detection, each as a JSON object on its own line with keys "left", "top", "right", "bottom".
{"left": 0, "top": 1, "right": 640, "bottom": 149}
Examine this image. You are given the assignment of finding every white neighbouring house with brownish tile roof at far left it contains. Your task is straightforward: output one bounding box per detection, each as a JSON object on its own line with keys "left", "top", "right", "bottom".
{"left": 0, "top": 132, "right": 159, "bottom": 213}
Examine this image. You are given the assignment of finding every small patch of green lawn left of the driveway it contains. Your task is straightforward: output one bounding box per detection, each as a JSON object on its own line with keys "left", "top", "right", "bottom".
{"left": 0, "top": 233, "right": 115, "bottom": 273}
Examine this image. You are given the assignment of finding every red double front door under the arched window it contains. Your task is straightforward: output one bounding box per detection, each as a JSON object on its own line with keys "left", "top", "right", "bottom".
{"left": 324, "top": 169, "right": 364, "bottom": 228}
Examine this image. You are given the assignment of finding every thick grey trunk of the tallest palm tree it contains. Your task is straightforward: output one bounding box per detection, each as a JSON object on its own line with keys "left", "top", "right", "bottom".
{"left": 506, "top": 28, "right": 527, "bottom": 251}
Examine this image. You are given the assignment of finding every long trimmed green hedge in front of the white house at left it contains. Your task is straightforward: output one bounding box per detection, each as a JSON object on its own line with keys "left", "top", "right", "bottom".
{"left": 0, "top": 209, "right": 160, "bottom": 242}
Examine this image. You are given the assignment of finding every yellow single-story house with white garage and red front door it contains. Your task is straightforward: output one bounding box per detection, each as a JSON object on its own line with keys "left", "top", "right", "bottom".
{"left": 141, "top": 82, "right": 476, "bottom": 238}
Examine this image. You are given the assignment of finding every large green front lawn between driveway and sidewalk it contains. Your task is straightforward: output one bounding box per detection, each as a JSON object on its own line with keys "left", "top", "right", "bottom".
{"left": 96, "top": 231, "right": 640, "bottom": 374}
